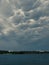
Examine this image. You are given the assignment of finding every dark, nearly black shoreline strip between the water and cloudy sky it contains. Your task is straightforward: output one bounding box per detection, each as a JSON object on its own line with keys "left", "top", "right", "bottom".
{"left": 0, "top": 50, "right": 49, "bottom": 54}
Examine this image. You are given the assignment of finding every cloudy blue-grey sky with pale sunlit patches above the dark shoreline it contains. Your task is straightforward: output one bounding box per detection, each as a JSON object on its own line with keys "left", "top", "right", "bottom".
{"left": 0, "top": 0, "right": 49, "bottom": 51}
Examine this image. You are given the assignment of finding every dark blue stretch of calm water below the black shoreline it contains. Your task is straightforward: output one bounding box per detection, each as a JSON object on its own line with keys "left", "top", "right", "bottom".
{"left": 0, "top": 54, "right": 49, "bottom": 65}
